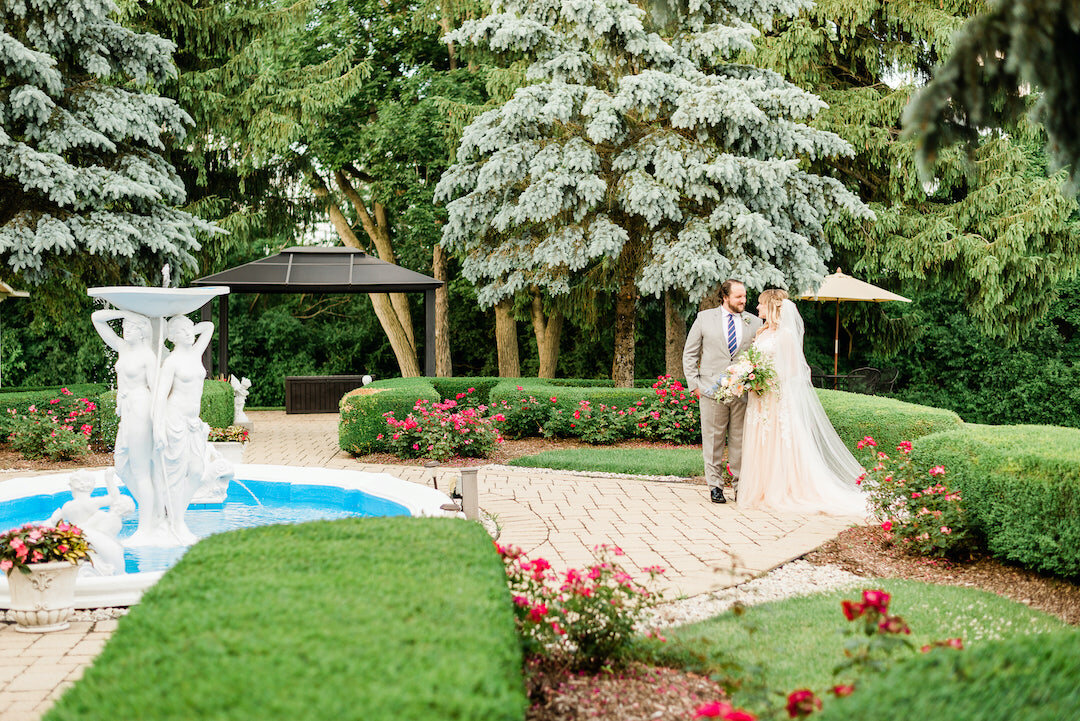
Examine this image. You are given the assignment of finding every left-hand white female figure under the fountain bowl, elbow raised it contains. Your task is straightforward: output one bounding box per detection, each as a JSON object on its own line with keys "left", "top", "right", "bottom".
{"left": 91, "top": 310, "right": 158, "bottom": 545}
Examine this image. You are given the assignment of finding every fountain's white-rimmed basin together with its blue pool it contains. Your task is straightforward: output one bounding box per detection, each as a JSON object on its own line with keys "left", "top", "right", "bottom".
{"left": 0, "top": 464, "right": 458, "bottom": 609}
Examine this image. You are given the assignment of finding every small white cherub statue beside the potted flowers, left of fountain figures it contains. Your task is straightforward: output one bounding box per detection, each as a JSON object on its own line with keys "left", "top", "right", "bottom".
{"left": 45, "top": 468, "right": 135, "bottom": 575}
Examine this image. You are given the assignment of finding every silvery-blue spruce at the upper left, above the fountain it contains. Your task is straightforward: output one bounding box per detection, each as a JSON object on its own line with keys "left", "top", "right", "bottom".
{"left": 0, "top": 0, "right": 214, "bottom": 285}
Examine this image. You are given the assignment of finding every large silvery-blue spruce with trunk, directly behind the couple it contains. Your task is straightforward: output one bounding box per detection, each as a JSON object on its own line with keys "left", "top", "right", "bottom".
{"left": 436, "top": 0, "right": 869, "bottom": 382}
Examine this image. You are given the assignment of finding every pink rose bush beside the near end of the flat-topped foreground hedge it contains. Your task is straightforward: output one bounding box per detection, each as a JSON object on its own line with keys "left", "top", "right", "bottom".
{"left": 496, "top": 544, "right": 663, "bottom": 670}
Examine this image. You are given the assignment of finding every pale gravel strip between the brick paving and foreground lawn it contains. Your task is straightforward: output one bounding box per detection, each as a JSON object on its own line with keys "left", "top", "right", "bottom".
{"left": 645, "top": 559, "right": 865, "bottom": 627}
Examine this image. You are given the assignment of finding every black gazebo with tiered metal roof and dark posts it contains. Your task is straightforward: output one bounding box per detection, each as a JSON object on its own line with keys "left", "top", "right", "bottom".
{"left": 191, "top": 246, "right": 443, "bottom": 376}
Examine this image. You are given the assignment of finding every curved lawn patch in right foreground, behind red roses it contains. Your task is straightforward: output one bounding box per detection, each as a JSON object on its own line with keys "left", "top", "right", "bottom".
{"left": 643, "top": 579, "right": 1066, "bottom": 703}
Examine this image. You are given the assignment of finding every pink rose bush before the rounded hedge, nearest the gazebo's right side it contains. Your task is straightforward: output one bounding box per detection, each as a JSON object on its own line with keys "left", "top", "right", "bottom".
{"left": 378, "top": 390, "right": 503, "bottom": 461}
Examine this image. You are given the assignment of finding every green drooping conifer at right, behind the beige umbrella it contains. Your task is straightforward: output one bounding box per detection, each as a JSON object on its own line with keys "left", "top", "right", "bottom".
{"left": 755, "top": 0, "right": 1080, "bottom": 346}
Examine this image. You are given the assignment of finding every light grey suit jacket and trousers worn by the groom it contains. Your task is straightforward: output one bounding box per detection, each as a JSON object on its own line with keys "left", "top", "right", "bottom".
{"left": 683, "top": 308, "right": 761, "bottom": 493}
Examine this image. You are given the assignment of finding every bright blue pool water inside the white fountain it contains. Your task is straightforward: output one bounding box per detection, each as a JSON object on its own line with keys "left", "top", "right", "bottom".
{"left": 0, "top": 480, "right": 410, "bottom": 573}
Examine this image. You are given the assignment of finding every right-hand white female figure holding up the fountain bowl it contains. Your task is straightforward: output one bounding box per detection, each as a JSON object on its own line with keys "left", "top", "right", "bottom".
{"left": 153, "top": 315, "right": 214, "bottom": 544}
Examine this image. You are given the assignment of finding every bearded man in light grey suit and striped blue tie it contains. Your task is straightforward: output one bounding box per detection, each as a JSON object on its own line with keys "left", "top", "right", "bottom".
{"left": 683, "top": 278, "right": 761, "bottom": 503}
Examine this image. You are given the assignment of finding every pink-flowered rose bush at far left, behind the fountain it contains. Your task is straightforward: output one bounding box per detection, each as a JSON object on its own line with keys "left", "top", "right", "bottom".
{"left": 8, "top": 389, "right": 97, "bottom": 461}
